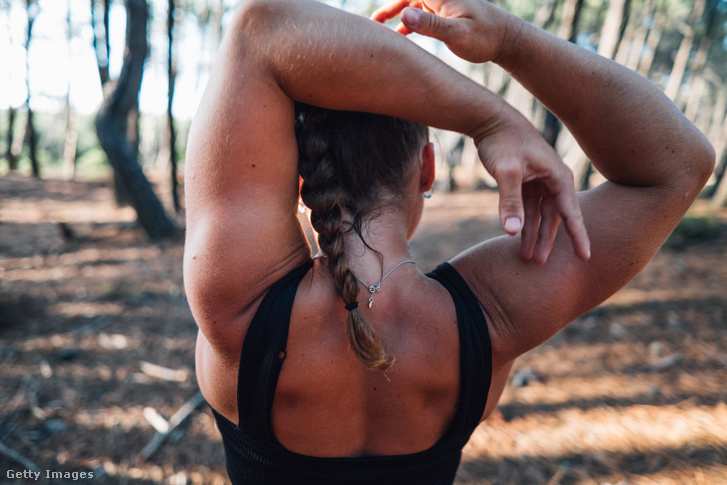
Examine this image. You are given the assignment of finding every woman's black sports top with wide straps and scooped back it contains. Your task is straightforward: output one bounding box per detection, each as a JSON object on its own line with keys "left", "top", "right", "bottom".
{"left": 212, "top": 261, "right": 492, "bottom": 485}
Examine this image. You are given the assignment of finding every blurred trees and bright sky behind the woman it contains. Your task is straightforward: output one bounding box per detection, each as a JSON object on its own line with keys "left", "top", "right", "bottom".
{"left": 0, "top": 0, "right": 727, "bottom": 238}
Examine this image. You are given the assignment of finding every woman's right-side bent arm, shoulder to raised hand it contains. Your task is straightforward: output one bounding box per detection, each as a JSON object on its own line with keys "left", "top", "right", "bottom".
{"left": 374, "top": 0, "right": 714, "bottom": 359}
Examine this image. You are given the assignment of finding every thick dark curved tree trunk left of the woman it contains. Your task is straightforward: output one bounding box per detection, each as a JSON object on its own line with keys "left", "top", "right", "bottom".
{"left": 96, "top": 0, "right": 174, "bottom": 239}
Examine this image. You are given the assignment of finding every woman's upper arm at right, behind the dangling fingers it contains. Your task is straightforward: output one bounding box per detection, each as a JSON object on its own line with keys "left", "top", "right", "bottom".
{"left": 452, "top": 178, "right": 697, "bottom": 362}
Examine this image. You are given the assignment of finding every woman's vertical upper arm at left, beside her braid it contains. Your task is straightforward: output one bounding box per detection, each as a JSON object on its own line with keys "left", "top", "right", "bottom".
{"left": 184, "top": 2, "right": 310, "bottom": 348}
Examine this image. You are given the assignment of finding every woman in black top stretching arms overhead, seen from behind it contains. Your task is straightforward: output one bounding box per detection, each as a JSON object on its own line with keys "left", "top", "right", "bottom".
{"left": 184, "top": 0, "right": 714, "bottom": 484}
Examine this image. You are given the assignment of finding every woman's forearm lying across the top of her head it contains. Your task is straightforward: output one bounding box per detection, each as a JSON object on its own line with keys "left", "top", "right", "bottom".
{"left": 233, "top": 0, "right": 507, "bottom": 137}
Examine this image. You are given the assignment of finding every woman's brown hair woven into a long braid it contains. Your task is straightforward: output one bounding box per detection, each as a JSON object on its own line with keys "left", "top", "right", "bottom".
{"left": 295, "top": 104, "right": 428, "bottom": 371}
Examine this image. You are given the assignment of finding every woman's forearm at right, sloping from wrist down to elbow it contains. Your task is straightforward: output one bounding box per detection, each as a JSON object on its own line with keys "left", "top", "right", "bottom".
{"left": 496, "top": 14, "right": 714, "bottom": 186}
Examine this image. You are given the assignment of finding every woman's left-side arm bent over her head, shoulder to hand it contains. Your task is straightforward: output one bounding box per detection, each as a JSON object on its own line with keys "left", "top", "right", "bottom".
{"left": 184, "top": 0, "right": 585, "bottom": 349}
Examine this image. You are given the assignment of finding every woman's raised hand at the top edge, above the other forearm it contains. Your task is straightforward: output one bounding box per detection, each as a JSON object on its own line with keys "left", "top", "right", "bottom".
{"left": 371, "top": 0, "right": 520, "bottom": 63}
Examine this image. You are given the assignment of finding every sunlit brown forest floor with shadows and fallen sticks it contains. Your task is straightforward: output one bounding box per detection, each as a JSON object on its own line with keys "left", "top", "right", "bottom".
{"left": 0, "top": 172, "right": 727, "bottom": 485}
